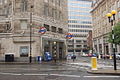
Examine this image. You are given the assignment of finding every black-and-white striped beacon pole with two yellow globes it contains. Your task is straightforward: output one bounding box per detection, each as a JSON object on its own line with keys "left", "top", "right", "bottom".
{"left": 107, "top": 10, "right": 117, "bottom": 70}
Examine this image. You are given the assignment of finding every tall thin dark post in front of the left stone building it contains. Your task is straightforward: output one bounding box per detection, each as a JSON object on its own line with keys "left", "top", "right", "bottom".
{"left": 29, "top": 5, "right": 33, "bottom": 63}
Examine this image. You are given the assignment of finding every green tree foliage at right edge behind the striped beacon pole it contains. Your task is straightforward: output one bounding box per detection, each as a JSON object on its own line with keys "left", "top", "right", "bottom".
{"left": 108, "top": 22, "right": 120, "bottom": 45}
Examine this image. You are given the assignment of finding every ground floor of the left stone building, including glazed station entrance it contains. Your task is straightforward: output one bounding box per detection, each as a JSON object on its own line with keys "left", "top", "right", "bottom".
{"left": 0, "top": 34, "right": 67, "bottom": 61}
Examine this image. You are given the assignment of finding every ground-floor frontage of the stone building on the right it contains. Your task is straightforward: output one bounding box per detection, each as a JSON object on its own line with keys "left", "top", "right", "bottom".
{"left": 93, "top": 36, "right": 120, "bottom": 55}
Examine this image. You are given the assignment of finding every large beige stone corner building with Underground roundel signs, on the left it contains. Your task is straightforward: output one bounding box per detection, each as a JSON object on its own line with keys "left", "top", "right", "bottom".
{"left": 0, "top": 0, "right": 68, "bottom": 61}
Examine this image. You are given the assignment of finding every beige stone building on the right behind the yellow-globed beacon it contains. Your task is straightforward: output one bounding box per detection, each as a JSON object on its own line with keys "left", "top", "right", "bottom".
{"left": 91, "top": 0, "right": 120, "bottom": 55}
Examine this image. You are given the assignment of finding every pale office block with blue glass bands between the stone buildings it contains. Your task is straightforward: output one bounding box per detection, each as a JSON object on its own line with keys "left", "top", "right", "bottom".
{"left": 68, "top": 0, "right": 92, "bottom": 54}
